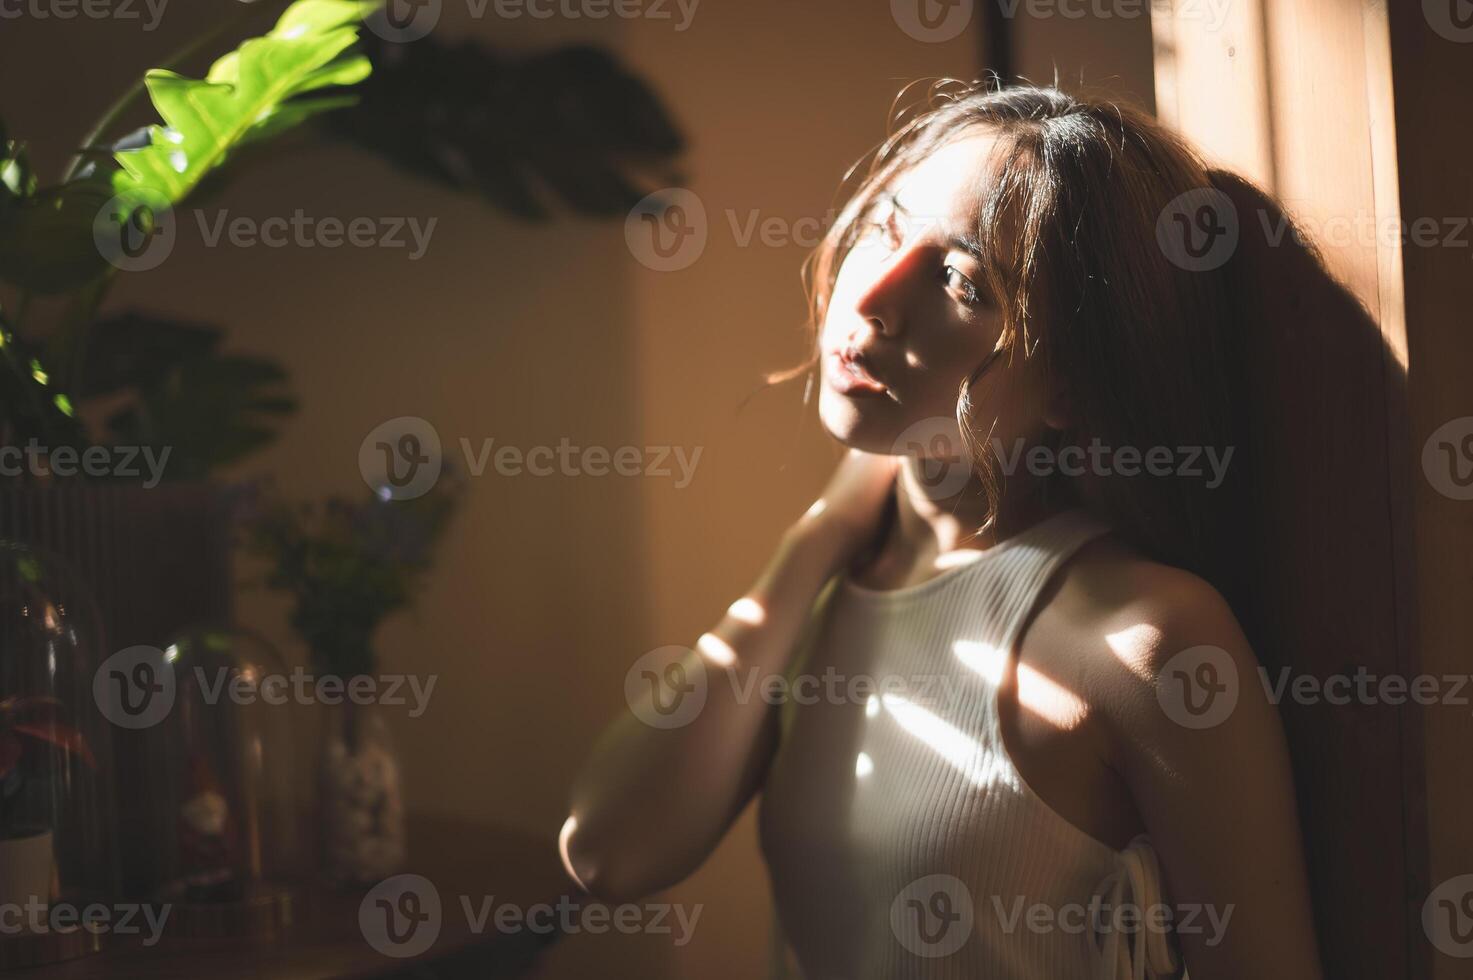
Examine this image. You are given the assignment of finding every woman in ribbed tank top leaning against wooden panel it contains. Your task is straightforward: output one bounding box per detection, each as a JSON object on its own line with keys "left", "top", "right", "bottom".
{"left": 561, "top": 85, "right": 1320, "bottom": 980}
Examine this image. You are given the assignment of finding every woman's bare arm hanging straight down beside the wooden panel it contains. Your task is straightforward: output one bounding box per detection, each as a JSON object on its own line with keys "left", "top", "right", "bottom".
{"left": 1114, "top": 569, "right": 1321, "bottom": 980}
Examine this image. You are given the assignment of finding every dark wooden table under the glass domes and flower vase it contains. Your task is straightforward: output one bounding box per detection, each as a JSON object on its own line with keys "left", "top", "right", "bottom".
{"left": 12, "top": 815, "right": 577, "bottom": 980}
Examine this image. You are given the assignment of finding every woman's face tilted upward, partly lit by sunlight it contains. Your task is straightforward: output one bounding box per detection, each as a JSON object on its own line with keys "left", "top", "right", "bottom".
{"left": 819, "top": 130, "right": 1047, "bottom": 458}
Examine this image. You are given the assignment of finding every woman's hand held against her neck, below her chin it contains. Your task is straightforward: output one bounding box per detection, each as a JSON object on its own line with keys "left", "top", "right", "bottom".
{"left": 790, "top": 449, "right": 899, "bottom": 573}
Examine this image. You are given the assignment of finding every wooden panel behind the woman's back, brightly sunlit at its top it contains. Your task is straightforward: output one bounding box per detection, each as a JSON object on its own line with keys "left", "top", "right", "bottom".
{"left": 1153, "top": 0, "right": 1427, "bottom": 980}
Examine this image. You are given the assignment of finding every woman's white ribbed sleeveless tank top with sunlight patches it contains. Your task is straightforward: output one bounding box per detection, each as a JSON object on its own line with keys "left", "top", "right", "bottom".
{"left": 759, "top": 510, "right": 1180, "bottom": 980}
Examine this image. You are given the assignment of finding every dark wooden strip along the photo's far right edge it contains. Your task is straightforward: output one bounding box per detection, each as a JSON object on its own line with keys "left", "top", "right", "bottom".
{"left": 1388, "top": 0, "right": 1473, "bottom": 980}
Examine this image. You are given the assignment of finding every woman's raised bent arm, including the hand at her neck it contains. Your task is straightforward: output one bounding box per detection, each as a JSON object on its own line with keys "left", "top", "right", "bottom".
{"left": 560, "top": 451, "right": 894, "bottom": 900}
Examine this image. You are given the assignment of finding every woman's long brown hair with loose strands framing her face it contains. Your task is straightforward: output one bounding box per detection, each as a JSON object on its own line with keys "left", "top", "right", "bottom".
{"left": 767, "top": 81, "right": 1343, "bottom": 618}
